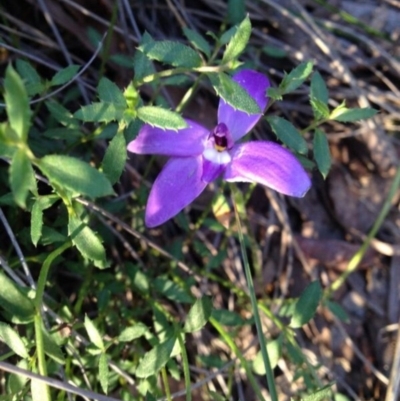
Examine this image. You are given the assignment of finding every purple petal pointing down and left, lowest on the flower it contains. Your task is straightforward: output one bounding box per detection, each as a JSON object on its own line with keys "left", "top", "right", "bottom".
{"left": 145, "top": 156, "right": 207, "bottom": 227}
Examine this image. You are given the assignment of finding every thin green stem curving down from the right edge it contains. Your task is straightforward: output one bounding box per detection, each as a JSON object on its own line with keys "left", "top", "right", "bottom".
{"left": 326, "top": 167, "right": 400, "bottom": 297}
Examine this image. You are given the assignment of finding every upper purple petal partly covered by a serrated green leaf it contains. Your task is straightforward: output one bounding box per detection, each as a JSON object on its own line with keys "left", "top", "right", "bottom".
{"left": 218, "top": 70, "right": 270, "bottom": 141}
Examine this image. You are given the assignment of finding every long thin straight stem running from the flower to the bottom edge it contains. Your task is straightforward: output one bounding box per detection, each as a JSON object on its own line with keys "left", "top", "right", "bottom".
{"left": 231, "top": 185, "right": 278, "bottom": 401}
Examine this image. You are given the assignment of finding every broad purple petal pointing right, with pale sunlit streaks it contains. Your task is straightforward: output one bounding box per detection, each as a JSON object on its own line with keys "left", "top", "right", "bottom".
{"left": 224, "top": 141, "right": 311, "bottom": 197}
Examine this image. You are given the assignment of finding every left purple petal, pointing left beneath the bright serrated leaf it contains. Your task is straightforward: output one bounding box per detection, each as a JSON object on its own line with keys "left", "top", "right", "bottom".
{"left": 128, "top": 120, "right": 210, "bottom": 156}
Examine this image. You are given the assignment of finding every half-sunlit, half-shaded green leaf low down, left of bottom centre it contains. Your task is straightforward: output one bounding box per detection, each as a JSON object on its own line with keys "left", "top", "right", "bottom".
{"left": 136, "top": 336, "right": 176, "bottom": 378}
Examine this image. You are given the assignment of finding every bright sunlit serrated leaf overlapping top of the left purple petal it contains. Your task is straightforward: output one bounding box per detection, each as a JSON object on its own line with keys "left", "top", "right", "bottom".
{"left": 137, "top": 106, "right": 187, "bottom": 130}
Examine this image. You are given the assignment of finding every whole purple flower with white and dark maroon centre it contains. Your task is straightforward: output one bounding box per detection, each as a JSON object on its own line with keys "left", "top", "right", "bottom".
{"left": 128, "top": 70, "right": 310, "bottom": 227}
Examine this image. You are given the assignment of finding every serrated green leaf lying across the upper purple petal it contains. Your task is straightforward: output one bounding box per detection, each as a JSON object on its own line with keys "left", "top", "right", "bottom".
{"left": 208, "top": 73, "right": 262, "bottom": 114}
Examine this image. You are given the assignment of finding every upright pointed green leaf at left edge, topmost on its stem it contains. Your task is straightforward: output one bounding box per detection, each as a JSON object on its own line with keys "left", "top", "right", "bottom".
{"left": 4, "top": 64, "right": 31, "bottom": 142}
